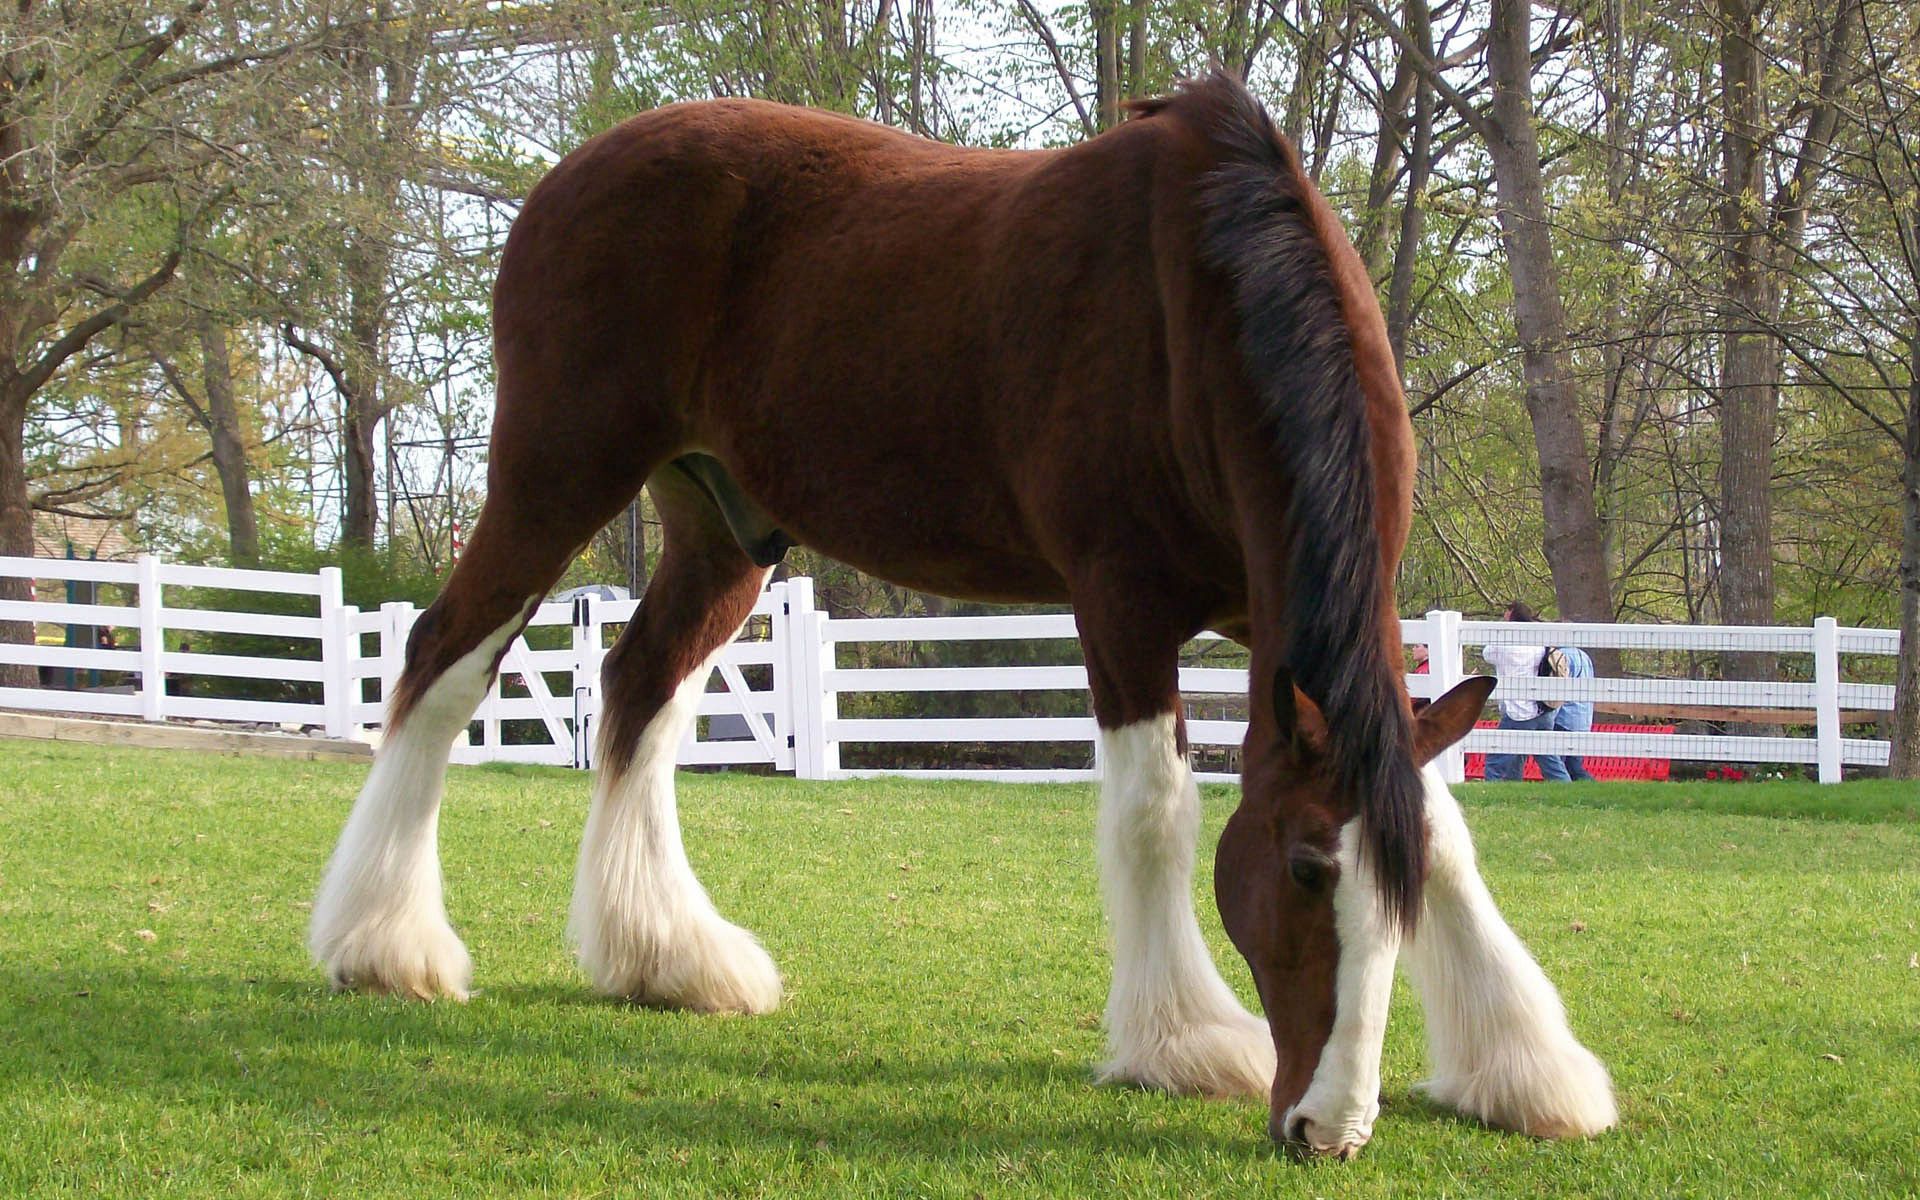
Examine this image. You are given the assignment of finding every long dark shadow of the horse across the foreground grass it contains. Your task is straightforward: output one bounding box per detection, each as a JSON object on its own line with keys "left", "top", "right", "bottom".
{"left": 0, "top": 968, "right": 1405, "bottom": 1162}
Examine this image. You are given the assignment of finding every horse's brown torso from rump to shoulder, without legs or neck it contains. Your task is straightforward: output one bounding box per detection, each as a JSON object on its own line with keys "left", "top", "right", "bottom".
{"left": 495, "top": 100, "right": 1228, "bottom": 597}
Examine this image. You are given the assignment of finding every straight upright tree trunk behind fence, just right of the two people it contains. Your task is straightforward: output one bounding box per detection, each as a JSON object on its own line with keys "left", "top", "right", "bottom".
{"left": 1720, "top": 0, "right": 1780, "bottom": 680}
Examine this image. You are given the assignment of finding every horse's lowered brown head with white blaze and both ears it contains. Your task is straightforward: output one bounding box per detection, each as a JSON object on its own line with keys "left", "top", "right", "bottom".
{"left": 1213, "top": 672, "right": 1494, "bottom": 1158}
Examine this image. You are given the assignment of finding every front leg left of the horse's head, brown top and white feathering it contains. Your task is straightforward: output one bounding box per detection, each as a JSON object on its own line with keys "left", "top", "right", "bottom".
{"left": 1075, "top": 602, "right": 1275, "bottom": 1096}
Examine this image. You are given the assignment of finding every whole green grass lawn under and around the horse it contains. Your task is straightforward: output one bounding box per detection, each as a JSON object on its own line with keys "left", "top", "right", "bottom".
{"left": 0, "top": 741, "right": 1920, "bottom": 1198}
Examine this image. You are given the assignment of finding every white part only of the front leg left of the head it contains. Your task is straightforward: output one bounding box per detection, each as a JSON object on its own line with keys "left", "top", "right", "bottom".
{"left": 1098, "top": 712, "right": 1273, "bottom": 1096}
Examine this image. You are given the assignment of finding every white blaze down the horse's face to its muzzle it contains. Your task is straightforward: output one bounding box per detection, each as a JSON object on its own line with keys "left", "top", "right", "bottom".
{"left": 1281, "top": 820, "right": 1400, "bottom": 1158}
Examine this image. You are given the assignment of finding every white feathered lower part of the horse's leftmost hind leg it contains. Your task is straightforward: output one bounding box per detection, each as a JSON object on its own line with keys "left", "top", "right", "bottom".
{"left": 307, "top": 597, "right": 540, "bottom": 1000}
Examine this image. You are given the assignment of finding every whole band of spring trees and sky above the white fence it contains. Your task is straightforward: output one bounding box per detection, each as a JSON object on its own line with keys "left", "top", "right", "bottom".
{"left": 0, "top": 0, "right": 1920, "bottom": 764}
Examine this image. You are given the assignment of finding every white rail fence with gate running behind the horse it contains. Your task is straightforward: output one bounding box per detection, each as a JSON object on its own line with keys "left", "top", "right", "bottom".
{"left": 0, "top": 557, "right": 1899, "bottom": 781}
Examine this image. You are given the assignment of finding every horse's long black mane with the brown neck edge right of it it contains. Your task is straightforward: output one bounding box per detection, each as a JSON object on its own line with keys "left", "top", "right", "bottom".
{"left": 1175, "top": 75, "right": 1427, "bottom": 929}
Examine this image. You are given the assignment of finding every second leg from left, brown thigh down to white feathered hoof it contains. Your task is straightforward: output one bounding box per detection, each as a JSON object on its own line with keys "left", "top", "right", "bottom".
{"left": 570, "top": 470, "right": 780, "bottom": 1012}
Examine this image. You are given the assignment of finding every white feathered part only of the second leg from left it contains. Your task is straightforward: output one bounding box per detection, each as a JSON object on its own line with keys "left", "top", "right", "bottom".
{"left": 568, "top": 637, "right": 780, "bottom": 1012}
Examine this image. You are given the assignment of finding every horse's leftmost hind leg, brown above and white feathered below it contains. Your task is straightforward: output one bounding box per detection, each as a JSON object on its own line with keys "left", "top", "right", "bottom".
{"left": 307, "top": 456, "right": 652, "bottom": 998}
